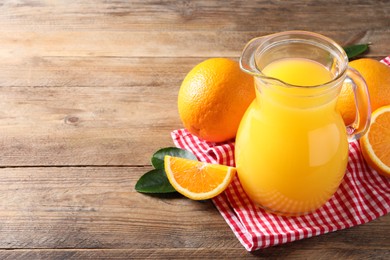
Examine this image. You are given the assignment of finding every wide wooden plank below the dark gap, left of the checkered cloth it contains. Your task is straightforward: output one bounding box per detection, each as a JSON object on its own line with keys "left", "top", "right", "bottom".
{"left": 0, "top": 167, "right": 241, "bottom": 249}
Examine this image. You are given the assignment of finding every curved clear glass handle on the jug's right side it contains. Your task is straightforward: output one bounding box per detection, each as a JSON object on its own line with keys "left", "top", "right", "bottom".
{"left": 344, "top": 67, "right": 371, "bottom": 142}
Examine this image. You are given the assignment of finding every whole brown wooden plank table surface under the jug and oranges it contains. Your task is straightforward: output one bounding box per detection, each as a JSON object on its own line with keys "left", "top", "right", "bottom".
{"left": 0, "top": 0, "right": 390, "bottom": 259}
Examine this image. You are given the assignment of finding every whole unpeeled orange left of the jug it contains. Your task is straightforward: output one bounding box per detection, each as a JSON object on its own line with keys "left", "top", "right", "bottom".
{"left": 178, "top": 58, "right": 255, "bottom": 142}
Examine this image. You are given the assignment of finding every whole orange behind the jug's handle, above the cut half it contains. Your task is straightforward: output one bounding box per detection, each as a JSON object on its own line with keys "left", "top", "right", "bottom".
{"left": 337, "top": 58, "right": 390, "bottom": 125}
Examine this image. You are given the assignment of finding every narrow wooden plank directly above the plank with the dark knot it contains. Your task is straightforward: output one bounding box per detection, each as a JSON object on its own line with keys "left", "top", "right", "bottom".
{"left": 0, "top": 57, "right": 204, "bottom": 87}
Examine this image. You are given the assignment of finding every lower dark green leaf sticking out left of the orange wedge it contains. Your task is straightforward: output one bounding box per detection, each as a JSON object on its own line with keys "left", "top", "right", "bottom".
{"left": 135, "top": 169, "right": 176, "bottom": 193}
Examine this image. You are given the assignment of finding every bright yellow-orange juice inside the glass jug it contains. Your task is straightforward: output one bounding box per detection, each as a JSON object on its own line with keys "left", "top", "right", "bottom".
{"left": 235, "top": 58, "right": 348, "bottom": 215}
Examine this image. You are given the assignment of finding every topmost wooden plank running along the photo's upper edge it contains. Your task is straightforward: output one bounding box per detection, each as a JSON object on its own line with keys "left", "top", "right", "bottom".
{"left": 0, "top": 0, "right": 390, "bottom": 33}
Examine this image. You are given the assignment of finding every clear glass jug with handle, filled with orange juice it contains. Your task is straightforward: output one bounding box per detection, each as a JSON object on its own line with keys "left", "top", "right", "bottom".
{"left": 235, "top": 31, "right": 371, "bottom": 216}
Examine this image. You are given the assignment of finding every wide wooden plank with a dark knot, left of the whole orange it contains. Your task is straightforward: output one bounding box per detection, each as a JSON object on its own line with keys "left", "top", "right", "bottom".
{"left": 0, "top": 85, "right": 182, "bottom": 166}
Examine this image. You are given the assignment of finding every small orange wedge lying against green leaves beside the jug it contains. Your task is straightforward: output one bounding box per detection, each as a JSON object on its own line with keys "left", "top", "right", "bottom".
{"left": 164, "top": 155, "right": 236, "bottom": 200}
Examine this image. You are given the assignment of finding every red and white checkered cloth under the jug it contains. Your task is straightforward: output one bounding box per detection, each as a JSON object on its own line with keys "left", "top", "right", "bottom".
{"left": 172, "top": 56, "right": 390, "bottom": 251}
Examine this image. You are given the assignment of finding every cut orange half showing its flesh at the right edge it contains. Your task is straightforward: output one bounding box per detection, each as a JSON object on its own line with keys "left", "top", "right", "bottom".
{"left": 360, "top": 105, "right": 390, "bottom": 177}
